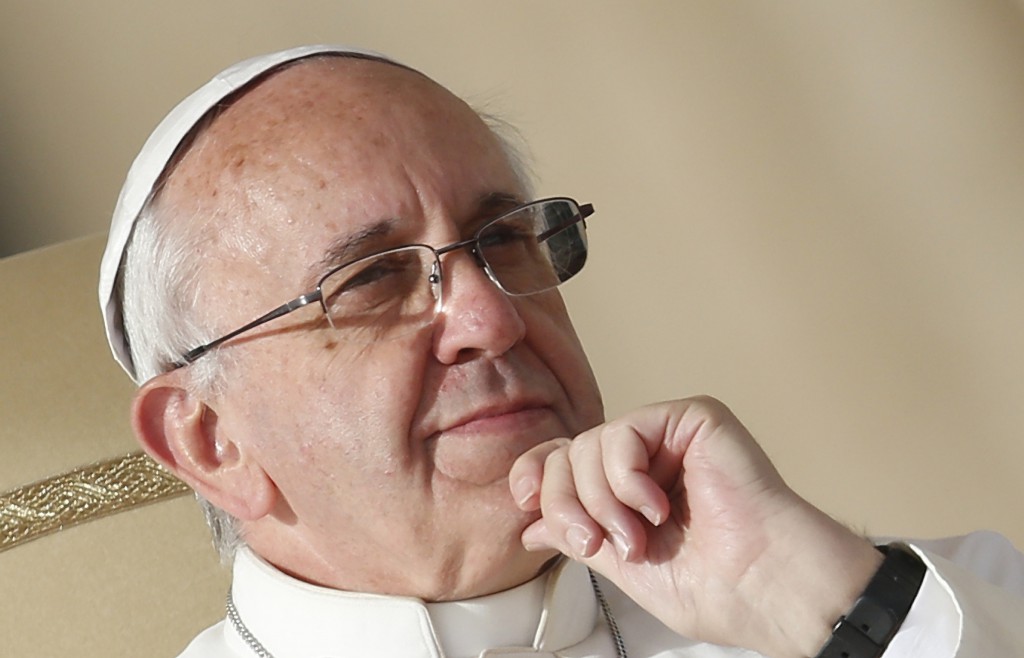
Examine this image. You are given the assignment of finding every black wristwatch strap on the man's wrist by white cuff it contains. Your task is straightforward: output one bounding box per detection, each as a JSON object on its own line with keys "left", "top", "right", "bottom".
{"left": 817, "top": 543, "right": 928, "bottom": 658}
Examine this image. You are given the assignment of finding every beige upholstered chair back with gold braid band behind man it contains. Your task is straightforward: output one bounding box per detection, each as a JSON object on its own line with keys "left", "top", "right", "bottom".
{"left": 0, "top": 236, "right": 229, "bottom": 658}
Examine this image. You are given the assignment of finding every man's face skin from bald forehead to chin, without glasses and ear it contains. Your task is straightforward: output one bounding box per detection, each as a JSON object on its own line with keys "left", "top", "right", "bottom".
{"left": 165, "top": 59, "right": 603, "bottom": 600}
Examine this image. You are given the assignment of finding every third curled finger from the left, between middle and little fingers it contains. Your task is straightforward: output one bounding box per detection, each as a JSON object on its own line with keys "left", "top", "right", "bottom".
{"left": 568, "top": 432, "right": 647, "bottom": 561}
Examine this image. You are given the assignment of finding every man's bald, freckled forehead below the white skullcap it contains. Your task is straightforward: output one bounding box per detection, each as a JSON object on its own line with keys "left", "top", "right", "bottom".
{"left": 162, "top": 57, "right": 519, "bottom": 278}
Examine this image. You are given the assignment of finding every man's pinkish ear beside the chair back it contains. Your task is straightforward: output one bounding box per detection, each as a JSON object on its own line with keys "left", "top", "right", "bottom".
{"left": 132, "top": 370, "right": 278, "bottom": 521}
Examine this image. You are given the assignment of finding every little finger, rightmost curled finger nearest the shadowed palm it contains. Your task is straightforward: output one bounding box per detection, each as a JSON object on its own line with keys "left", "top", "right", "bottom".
{"left": 600, "top": 423, "right": 669, "bottom": 526}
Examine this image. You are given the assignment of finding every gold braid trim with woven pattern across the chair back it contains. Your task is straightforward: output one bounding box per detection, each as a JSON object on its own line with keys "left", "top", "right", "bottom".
{"left": 0, "top": 452, "right": 189, "bottom": 553}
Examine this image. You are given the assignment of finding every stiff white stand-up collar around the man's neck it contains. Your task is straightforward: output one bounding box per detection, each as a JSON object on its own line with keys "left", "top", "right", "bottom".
{"left": 223, "top": 549, "right": 598, "bottom": 658}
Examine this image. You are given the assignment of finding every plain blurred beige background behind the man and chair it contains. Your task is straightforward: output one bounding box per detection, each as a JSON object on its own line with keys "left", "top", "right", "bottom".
{"left": 0, "top": 0, "right": 1024, "bottom": 556}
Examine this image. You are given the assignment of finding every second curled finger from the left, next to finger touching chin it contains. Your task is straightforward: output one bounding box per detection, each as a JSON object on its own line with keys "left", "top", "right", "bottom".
{"left": 541, "top": 447, "right": 604, "bottom": 559}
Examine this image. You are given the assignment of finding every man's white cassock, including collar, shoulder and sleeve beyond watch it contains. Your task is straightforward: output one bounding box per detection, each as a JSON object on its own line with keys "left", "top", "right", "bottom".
{"left": 181, "top": 532, "right": 1024, "bottom": 658}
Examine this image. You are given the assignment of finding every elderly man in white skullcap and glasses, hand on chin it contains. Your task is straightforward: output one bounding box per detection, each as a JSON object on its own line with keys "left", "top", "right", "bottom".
{"left": 100, "top": 47, "right": 1024, "bottom": 658}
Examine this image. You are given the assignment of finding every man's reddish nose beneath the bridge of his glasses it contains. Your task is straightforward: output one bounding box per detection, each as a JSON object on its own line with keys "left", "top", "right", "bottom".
{"left": 433, "top": 250, "right": 526, "bottom": 364}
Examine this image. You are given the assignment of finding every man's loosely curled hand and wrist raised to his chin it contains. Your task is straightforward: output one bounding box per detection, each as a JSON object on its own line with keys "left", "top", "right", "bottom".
{"left": 509, "top": 398, "right": 881, "bottom": 657}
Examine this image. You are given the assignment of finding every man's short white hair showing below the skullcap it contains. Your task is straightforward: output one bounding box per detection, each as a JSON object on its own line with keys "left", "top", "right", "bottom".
{"left": 119, "top": 77, "right": 534, "bottom": 564}
